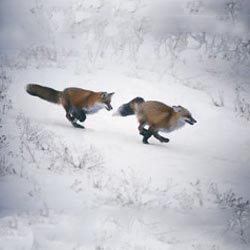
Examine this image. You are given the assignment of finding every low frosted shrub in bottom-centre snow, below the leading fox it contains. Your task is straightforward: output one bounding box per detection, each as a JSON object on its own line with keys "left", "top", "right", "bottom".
{"left": 93, "top": 168, "right": 174, "bottom": 208}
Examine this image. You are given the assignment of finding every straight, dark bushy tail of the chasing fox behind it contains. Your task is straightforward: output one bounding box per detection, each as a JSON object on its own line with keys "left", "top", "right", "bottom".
{"left": 26, "top": 84, "right": 62, "bottom": 104}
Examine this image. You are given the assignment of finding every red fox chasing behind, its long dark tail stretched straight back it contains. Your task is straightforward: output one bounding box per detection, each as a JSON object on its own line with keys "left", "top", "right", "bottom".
{"left": 26, "top": 84, "right": 114, "bottom": 128}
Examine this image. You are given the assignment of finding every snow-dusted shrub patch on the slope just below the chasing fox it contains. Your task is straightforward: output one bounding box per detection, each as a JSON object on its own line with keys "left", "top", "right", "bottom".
{"left": 16, "top": 114, "right": 103, "bottom": 173}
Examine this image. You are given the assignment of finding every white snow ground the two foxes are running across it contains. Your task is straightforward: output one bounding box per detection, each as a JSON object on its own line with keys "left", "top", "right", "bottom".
{"left": 0, "top": 69, "right": 250, "bottom": 250}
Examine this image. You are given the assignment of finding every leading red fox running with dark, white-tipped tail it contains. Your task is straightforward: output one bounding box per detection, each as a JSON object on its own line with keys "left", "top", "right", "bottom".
{"left": 114, "top": 97, "right": 197, "bottom": 144}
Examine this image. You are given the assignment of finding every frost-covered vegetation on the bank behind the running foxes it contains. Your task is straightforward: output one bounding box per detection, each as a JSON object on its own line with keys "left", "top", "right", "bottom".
{"left": 1, "top": 0, "right": 250, "bottom": 119}
